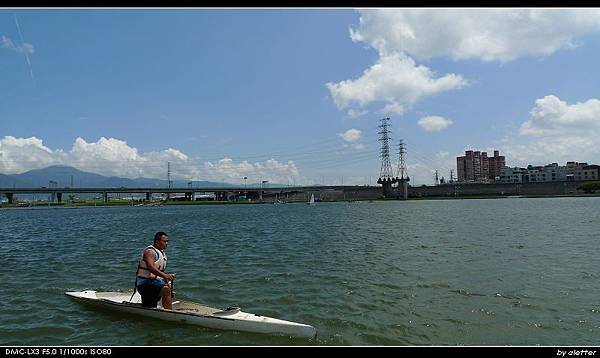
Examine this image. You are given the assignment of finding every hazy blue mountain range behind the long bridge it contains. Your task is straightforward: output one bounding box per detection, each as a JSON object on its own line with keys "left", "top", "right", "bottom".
{"left": 0, "top": 165, "right": 237, "bottom": 188}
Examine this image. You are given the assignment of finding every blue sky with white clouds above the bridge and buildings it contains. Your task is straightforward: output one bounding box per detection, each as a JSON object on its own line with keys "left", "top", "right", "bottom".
{"left": 0, "top": 9, "right": 600, "bottom": 184}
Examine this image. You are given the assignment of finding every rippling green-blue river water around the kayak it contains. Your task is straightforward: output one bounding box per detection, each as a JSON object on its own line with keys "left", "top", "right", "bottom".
{"left": 0, "top": 198, "right": 600, "bottom": 345}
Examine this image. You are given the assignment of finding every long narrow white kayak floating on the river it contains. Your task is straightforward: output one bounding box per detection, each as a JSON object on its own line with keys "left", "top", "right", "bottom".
{"left": 65, "top": 290, "right": 317, "bottom": 338}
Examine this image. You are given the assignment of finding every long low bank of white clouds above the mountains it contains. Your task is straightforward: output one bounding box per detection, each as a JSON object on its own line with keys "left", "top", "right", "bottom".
{"left": 0, "top": 136, "right": 300, "bottom": 184}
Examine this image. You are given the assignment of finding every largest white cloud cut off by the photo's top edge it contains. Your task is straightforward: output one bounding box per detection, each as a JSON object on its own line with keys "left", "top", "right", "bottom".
{"left": 350, "top": 9, "right": 600, "bottom": 62}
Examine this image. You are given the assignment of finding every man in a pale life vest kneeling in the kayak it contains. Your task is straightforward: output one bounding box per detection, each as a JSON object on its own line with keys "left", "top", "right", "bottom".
{"left": 135, "top": 231, "right": 175, "bottom": 309}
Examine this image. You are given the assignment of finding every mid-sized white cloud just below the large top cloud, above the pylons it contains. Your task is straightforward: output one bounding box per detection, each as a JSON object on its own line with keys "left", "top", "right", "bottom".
{"left": 326, "top": 53, "right": 467, "bottom": 114}
